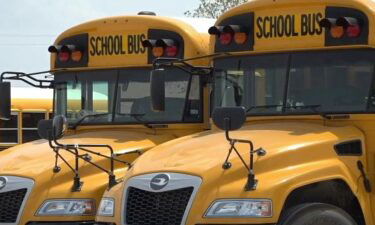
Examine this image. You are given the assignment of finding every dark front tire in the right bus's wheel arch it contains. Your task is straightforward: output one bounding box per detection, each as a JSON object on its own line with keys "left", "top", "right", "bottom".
{"left": 277, "top": 203, "right": 357, "bottom": 225}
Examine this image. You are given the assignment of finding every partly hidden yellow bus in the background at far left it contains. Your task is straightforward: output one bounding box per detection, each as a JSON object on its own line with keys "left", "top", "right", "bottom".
{"left": 0, "top": 87, "right": 52, "bottom": 151}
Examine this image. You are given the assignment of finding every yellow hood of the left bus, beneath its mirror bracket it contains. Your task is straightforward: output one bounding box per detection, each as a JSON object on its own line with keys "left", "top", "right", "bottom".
{"left": 0, "top": 130, "right": 176, "bottom": 185}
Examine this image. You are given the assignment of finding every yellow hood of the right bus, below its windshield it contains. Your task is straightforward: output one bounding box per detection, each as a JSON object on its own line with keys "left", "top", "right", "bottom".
{"left": 129, "top": 122, "right": 364, "bottom": 178}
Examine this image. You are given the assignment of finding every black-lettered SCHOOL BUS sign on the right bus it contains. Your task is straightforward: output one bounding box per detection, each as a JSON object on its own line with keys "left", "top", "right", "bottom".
{"left": 254, "top": 7, "right": 325, "bottom": 50}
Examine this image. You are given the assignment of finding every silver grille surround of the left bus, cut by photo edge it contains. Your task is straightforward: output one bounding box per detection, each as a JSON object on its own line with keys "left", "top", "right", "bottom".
{"left": 0, "top": 175, "right": 35, "bottom": 225}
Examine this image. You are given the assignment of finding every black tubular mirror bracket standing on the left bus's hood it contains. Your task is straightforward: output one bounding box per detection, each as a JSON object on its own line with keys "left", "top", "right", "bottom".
{"left": 49, "top": 131, "right": 136, "bottom": 192}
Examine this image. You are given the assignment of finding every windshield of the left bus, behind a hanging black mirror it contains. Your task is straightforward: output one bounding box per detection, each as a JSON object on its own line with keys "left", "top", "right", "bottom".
{"left": 55, "top": 69, "right": 202, "bottom": 124}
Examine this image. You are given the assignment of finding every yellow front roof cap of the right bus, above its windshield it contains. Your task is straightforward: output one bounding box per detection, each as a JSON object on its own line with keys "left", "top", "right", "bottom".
{"left": 211, "top": 0, "right": 375, "bottom": 52}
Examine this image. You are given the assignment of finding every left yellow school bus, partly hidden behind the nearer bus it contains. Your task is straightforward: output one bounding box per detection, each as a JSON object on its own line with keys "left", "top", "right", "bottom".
{"left": 0, "top": 13, "right": 214, "bottom": 225}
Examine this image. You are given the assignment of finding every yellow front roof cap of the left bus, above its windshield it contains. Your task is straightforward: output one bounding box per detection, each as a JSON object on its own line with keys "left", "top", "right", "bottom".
{"left": 51, "top": 15, "right": 214, "bottom": 69}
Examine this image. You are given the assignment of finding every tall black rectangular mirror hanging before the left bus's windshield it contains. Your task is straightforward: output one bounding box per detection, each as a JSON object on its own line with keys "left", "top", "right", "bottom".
{"left": 150, "top": 69, "right": 165, "bottom": 112}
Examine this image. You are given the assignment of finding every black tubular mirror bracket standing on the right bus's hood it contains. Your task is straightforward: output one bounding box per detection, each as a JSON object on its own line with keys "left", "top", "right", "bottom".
{"left": 223, "top": 121, "right": 266, "bottom": 191}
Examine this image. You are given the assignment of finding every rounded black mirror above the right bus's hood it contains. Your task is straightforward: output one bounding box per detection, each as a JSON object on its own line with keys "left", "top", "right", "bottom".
{"left": 212, "top": 107, "right": 246, "bottom": 131}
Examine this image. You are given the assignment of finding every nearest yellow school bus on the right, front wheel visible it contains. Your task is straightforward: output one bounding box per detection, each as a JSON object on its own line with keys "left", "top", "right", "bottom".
{"left": 97, "top": 0, "right": 375, "bottom": 225}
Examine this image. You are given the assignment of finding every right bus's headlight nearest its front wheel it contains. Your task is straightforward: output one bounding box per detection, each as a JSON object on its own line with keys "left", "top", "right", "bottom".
{"left": 205, "top": 199, "right": 272, "bottom": 217}
